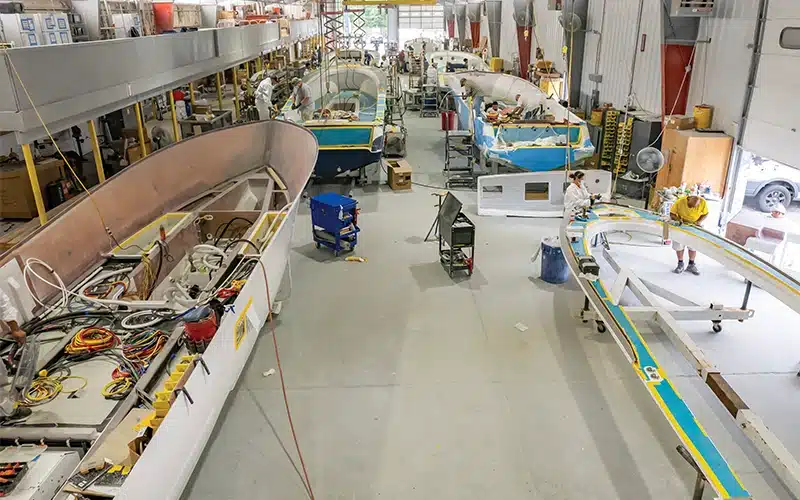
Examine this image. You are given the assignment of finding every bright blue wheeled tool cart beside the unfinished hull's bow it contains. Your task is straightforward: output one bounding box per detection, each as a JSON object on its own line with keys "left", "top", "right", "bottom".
{"left": 311, "top": 193, "right": 361, "bottom": 257}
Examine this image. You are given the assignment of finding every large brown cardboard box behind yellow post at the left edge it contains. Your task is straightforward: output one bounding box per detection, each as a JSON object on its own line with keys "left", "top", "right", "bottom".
{"left": 0, "top": 158, "right": 64, "bottom": 219}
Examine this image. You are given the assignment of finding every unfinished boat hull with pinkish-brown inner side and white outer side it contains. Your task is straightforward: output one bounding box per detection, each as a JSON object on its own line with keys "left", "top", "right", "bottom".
{"left": 0, "top": 121, "right": 317, "bottom": 500}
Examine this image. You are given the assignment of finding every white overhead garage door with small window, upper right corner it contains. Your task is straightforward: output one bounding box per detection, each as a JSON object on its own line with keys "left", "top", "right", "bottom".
{"left": 742, "top": 0, "right": 800, "bottom": 168}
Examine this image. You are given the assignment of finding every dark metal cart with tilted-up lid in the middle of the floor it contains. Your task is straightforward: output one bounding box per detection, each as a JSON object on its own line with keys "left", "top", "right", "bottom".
{"left": 438, "top": 193, "right": 475, "bottom": 278}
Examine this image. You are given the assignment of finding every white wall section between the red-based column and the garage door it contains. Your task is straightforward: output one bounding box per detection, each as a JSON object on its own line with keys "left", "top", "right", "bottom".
{"left": 688, "top": 0, "right": 760, "bottom": 136}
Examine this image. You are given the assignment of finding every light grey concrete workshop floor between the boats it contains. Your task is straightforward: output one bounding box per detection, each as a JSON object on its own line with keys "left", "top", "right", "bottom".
{"left": 185, "top": 117, "right": 800, "bottom": 500}
